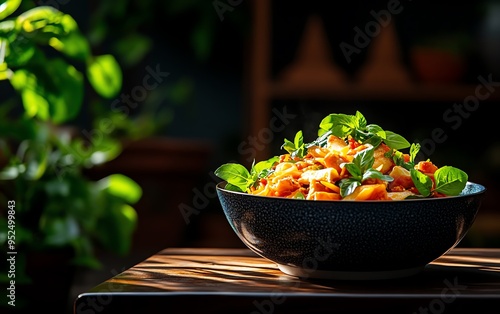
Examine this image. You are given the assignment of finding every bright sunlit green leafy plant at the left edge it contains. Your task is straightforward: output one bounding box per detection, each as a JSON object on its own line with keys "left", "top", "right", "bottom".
{"left": 0, "top": 0, "right": 142, "bottom": 313}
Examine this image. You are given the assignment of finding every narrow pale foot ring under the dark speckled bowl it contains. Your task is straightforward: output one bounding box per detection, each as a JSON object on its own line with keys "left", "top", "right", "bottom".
{"left": 278, "top": 264, "right": 425, "bottom": 280}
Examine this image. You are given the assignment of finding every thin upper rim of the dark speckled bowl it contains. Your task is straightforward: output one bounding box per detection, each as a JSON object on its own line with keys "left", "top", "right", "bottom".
{"left": 216, "top": 181, "right": 487, "bottom": 204}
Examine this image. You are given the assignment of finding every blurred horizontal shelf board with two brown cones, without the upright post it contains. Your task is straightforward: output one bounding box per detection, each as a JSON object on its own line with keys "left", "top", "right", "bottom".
{"left": 266, "top": 15, "right": 500, "bottom": 101}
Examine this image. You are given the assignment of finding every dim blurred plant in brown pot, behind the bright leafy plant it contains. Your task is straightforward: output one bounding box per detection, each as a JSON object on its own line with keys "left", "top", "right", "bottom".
{"left": 79, "top": 0, "right": 219, "bottom": 255}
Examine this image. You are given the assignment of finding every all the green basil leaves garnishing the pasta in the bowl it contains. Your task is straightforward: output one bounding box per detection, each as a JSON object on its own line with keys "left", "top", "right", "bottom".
{"left": 215, "top": 111, "right": 468, "bottom": 199}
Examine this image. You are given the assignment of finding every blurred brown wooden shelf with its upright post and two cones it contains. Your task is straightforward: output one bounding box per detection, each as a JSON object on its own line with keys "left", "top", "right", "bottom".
{"left": 245, "top": 0, "right": 500, "bottom": 160}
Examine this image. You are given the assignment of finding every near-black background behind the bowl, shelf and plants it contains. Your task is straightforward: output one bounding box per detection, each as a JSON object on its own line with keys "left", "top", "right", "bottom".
{"left": 4, "top": 0, "right": 500, "bottom": 310}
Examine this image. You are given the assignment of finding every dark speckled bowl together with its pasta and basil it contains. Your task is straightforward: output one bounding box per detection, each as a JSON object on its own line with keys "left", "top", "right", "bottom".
{"left": 215, "top": 112, "right": 486, "bottom": 280}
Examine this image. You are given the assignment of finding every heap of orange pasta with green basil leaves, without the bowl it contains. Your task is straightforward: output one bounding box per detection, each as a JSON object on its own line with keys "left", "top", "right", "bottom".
{"left": 215, "top": 111, "right": 468, "bottom": 201}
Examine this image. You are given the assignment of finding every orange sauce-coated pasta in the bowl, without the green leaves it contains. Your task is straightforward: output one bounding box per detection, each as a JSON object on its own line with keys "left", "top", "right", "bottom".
{"left": 248, "top": 135, "right": 440, "bottom": 201}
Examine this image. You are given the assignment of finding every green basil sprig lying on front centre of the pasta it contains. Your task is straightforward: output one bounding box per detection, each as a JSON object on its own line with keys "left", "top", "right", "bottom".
{"left": 339, "top": 147, "right": 394, "bottom": 197}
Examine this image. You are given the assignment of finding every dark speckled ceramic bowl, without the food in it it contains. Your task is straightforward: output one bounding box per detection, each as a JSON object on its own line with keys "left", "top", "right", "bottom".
{"left": 217, "top": 182, "right": 486, "bottom": 280}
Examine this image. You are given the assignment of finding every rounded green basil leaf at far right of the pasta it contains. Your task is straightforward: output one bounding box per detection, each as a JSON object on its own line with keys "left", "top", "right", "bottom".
{"left": 434, "top": 166, "right": 469, "bottom": 196}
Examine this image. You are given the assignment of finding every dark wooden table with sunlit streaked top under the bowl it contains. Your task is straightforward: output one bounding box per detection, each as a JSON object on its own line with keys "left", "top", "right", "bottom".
{"left": 74, "top": 248, "right": 500, "bottom": 314}
